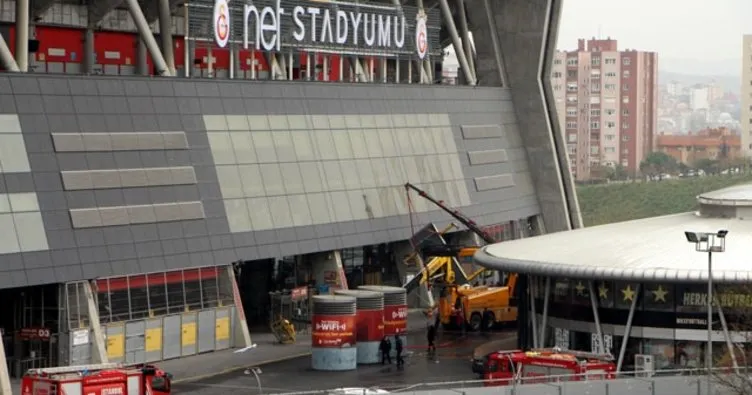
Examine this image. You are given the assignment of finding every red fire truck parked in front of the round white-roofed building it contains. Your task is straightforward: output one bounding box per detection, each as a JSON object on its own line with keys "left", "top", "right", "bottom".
{"left": 473, "top": 348, "right": 616, "bottom": 386}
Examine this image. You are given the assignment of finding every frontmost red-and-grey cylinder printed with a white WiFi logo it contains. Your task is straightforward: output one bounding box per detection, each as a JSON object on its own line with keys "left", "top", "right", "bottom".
{"left": 311, "top": 295, "right": 358, "bottom": 371}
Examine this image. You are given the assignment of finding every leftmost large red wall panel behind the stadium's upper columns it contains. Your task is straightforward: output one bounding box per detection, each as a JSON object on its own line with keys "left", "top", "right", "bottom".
{"left": 35, "top": 26, "right": 84, "bottom": 63}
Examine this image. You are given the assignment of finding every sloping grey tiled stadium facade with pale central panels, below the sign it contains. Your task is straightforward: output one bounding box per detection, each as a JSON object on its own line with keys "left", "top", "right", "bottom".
{"left": 0, "top": 75, "right": 540, "bottom": 286}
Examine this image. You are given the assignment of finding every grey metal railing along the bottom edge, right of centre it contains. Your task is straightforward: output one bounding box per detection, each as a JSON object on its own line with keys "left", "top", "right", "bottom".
{"left": 270, "top": 367, "right": 752, "bottom": 395}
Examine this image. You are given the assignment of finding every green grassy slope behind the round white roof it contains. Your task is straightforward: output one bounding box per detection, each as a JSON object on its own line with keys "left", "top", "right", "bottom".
{"left": 577, "top": 174, "right": 752, "bottom": 226}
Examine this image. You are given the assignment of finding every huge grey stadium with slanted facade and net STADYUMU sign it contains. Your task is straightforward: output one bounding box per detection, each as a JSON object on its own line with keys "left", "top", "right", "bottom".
{"left": 0, "top": 0, "right": 580, "bottom": 382}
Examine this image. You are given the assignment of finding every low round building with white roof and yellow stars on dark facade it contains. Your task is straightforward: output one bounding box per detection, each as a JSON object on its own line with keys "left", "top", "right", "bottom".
{"left": 475, "top": 184, "right": 752, "bottom": 376}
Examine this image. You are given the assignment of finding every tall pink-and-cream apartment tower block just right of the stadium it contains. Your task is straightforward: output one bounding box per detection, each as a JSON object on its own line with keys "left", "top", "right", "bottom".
{"left": 551, "top": 38, "right": 658, "bottom": 181}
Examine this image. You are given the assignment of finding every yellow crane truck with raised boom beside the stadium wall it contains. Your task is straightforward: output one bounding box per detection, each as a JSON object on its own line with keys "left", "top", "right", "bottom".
{"left": 404, "top": 182, "right": 517, "bottom": 330}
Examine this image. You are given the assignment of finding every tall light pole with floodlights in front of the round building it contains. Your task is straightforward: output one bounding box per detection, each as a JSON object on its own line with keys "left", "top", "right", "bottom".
{"left": 684, "top": 229, "right": 728, "bottom": 395}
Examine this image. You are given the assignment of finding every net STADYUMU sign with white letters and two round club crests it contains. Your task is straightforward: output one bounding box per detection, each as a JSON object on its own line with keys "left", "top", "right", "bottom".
{"left": 203, "top": 0, "right": 441, "bottom": 59}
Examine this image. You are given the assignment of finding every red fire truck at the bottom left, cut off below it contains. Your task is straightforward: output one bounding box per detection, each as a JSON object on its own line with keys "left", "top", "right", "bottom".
{"left": 21, "top": 363, "right": 171, "bottom": 395}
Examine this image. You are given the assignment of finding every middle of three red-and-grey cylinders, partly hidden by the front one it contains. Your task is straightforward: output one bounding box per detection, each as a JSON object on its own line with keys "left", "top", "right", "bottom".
{"left": 334, "top": 289, "right": 384, "bottom": 364}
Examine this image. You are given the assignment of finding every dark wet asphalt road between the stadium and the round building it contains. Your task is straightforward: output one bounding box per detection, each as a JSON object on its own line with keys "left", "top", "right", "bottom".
{"left": 173, "top": 333, "right": 516, "bottom": 395}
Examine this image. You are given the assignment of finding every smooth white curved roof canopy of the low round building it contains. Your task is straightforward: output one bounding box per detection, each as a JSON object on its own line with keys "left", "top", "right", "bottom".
{"left": 475, "top": 213, "right": 752, "bottom": 283}
